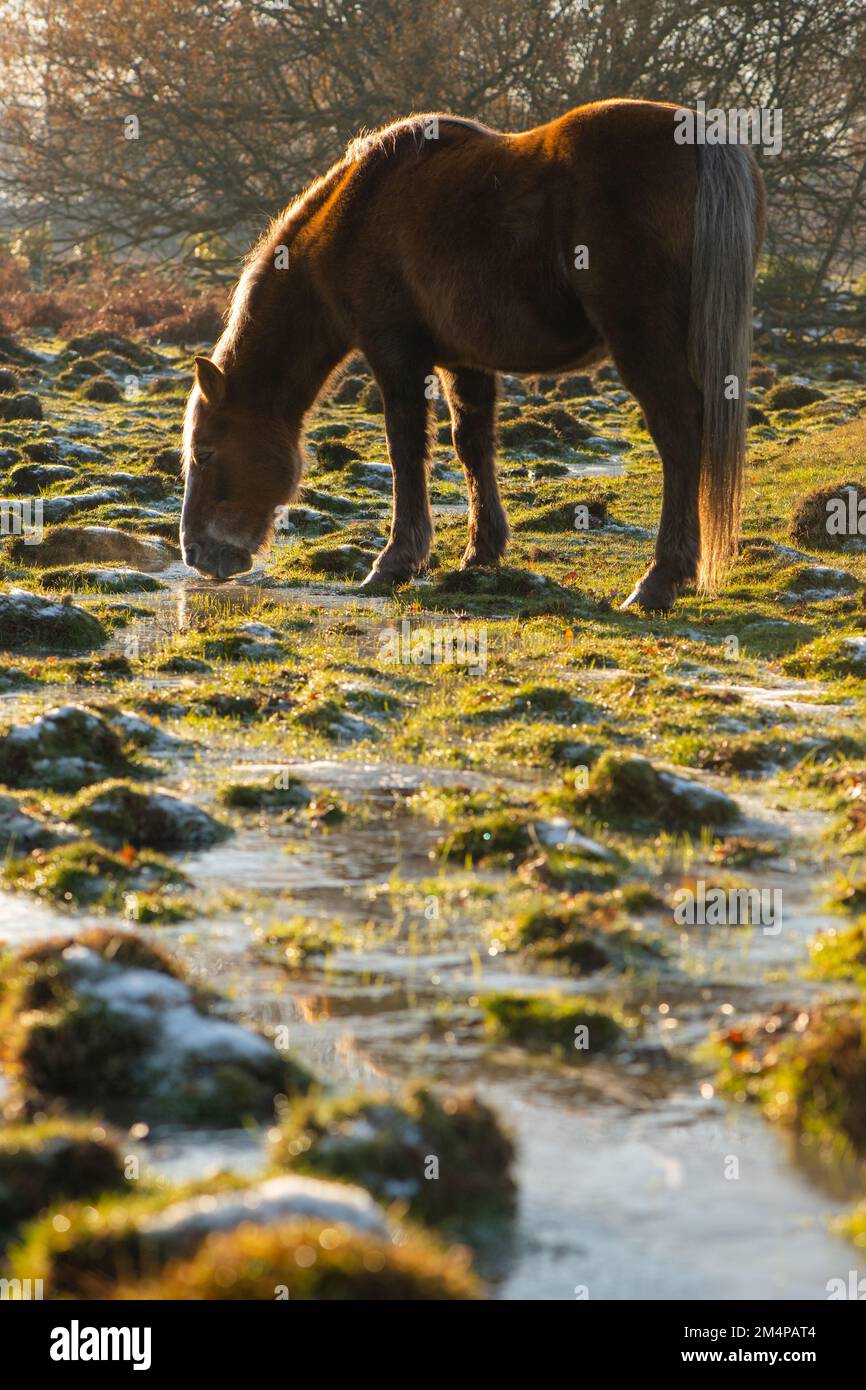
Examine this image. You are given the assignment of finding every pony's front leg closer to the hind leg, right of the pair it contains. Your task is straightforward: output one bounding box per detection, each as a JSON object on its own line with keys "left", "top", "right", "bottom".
{"left": 439, "top": 367, "right": 509, "bottom": 570}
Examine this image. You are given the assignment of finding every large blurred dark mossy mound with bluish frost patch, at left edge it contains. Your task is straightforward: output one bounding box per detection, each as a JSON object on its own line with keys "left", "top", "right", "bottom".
{"left": 0, "top": 929, "right": 309, "bottom": 1126}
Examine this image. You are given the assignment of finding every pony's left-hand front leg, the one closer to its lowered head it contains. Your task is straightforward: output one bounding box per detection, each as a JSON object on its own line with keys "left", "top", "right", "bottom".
{"left": 364, "top": 353, "right": 432, "bottom": 585}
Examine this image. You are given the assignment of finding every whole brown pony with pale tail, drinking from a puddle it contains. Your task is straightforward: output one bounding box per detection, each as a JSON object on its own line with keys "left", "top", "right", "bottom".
{"left": 182, "top": 100, "right": 763, "bottom": 612}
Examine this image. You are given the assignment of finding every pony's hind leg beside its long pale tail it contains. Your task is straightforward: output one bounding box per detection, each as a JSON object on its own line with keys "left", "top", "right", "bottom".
{"left": 607, "top": 329, "right": 703, "bottom": 613}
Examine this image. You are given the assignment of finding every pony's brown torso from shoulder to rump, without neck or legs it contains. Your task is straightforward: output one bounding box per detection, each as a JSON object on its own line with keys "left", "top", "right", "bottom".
{"left": 318, "top": 100, "right": 706, "bottom": 371}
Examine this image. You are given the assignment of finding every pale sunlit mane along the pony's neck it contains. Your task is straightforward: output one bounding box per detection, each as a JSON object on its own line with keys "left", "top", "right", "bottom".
{"left": 221, "top": 111, "right": 495, "bottom": 354}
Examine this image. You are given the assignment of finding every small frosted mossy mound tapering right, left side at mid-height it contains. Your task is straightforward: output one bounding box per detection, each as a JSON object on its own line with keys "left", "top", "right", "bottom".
{"left": 70, "top": 781, "right": 229, "bottom": 852}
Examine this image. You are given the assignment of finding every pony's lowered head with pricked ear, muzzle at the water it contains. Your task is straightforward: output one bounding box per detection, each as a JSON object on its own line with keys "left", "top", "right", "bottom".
{"left": 181, "top": 357, "right": 300, "bottom": 580}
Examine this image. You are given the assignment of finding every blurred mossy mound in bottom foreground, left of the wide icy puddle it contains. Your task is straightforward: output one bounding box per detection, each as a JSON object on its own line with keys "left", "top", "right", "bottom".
{"left": 271, "top": 1084, "right": 514, "bottom": 1225}
